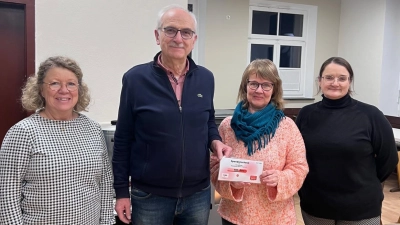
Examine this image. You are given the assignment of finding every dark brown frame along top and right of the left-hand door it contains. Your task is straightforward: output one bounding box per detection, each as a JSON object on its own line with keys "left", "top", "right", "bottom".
{"left": 0, "top": 0, "right": 35, "bottom": 82}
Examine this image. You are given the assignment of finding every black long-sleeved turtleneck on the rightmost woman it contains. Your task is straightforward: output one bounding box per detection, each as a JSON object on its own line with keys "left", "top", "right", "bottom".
{"left": 296, "top": 95, "right": 398, "bottom": 221}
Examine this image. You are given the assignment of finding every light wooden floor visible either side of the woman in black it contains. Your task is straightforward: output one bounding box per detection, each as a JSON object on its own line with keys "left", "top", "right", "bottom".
{"left": 294, "top": 174, "right": 400, "bottom": 225}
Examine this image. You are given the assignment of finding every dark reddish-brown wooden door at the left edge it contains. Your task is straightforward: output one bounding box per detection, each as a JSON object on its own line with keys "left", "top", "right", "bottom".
{"left": 0, "top": 0, "right": 35, "bottom": 143}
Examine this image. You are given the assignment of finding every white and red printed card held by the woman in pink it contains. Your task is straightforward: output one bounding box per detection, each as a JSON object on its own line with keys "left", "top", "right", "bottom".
{"left": 218, "top": 157, "right": 264, "bottom": 183}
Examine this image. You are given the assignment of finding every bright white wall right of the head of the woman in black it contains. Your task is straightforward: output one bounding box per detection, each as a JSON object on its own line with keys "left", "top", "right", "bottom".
{"left": 338, "top": 0, "right": 386, "bottom": 106}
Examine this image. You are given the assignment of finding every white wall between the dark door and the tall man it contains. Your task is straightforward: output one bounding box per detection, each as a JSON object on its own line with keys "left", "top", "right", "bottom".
{"left": 35, "top": 0, "right": 187, "bottom": 123}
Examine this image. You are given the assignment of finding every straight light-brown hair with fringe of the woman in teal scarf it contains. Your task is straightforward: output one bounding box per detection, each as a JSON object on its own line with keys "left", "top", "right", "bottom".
{"left": 237, "top": 59, "right": 284, "bottom": 110}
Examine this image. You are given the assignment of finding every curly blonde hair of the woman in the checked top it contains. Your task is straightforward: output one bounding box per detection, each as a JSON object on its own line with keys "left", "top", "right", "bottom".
{"left": 21, "top": 56, "right": 90, "bottom": 112}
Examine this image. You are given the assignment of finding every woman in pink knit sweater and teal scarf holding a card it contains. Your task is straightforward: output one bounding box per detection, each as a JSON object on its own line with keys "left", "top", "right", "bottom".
{"left": 210, "top": 59, "right": 308, "bottom": 225}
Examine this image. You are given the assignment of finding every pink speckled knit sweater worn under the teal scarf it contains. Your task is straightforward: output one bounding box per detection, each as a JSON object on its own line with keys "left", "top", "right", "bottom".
{"left": 211, "top": 117, "right": 308, "bottom": 225}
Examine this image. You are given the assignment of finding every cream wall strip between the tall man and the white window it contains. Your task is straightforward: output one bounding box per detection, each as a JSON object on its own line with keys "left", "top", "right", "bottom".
{"left": 205, "top": 0, "right": 249, "bottom": 109}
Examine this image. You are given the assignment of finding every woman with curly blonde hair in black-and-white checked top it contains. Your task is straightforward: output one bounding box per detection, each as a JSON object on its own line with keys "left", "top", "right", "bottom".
{"left": 0, "top": 56, "right": 115, "bottom": 224}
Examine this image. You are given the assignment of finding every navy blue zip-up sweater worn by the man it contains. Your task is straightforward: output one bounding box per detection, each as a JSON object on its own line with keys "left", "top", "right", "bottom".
{"left": 113, "top": 53, "right": 221, "bottom": 198}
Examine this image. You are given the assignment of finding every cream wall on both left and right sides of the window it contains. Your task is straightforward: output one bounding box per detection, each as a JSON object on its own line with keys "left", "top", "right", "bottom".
{"left": 205, "top": 0, "right": 340, "bottom": 108}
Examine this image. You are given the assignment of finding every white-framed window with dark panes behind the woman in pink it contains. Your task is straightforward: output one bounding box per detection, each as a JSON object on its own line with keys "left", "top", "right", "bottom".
{"left": 248, "top": 0, "right": 317, "bottom": 98}
